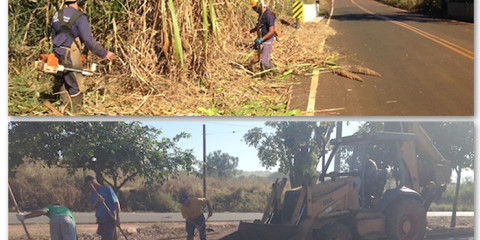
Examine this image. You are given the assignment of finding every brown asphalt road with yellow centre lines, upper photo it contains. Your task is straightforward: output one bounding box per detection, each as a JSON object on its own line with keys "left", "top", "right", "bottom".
{"left": 291, "top": 0, "right": 474, "bottom": 116}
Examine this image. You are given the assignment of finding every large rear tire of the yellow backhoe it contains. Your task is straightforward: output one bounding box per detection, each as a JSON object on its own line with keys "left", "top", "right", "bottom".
{"left": 385, "top": 198, "right": 427, "bottom": 240}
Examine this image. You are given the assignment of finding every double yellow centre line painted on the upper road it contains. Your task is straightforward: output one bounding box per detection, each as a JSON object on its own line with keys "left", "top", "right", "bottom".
{"left": 350, "top": 0, "right": 474, "bottom": 60}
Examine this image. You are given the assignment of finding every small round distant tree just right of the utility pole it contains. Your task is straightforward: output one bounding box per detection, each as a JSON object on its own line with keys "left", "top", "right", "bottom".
{"left": 207, "top": 150, "right": 238, "bottom": 177}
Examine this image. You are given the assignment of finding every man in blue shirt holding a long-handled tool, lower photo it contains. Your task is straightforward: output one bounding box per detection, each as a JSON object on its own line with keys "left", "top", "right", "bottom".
{"left": 85, "top": 176, "right": 120, "bottom": 240}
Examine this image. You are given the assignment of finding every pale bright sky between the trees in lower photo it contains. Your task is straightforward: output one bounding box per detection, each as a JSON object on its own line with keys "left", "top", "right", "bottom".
{"left": 142, "top": 121, "right": 360, "bottom": 171}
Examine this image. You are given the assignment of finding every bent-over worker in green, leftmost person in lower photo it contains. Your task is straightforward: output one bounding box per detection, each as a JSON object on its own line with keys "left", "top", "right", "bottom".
{"left": 17, "top": 204, "right": 77, "bottom": 240}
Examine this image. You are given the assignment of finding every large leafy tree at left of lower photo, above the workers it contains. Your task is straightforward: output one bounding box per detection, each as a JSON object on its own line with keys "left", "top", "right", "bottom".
{"left": 9, "top": 122, "right": 196, "bottom": 192}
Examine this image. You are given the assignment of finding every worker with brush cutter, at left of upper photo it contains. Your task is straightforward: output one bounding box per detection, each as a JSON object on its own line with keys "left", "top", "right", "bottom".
{"left": 52, "top": 0, "right": 115, "bottom": 112}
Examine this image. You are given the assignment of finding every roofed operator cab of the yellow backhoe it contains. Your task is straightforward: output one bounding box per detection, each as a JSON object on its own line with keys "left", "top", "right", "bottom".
{"left": 319, "top": 132, "right": 415, "bottom": 209}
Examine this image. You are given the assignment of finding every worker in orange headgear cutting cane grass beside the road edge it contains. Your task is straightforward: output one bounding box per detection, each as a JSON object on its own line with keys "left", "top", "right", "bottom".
{"left": 246, "top": 0, "right": 276, "bottom": 70}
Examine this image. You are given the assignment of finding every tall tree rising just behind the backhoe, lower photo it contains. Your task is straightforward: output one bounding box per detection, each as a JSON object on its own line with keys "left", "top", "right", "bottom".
{"left": 244, "top": 122, "right": 334, "bottom": 187}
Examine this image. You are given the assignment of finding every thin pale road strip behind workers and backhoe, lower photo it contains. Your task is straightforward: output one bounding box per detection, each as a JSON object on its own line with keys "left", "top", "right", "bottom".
{"left": 8, "top": 212, "right": 473, "bottom": 224}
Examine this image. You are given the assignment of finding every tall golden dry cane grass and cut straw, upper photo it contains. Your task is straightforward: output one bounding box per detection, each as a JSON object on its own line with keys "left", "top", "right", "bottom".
{"left": 9, "top": 0, "right": 336, "bottom": 116}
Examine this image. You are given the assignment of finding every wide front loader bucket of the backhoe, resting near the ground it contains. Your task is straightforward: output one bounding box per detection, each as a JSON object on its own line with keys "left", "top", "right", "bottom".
{"left": 220, "top": 222, "right": 299, "bottom": 240}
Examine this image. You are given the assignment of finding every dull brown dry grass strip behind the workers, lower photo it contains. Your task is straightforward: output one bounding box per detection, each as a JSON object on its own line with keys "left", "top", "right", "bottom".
{"left": 9, "top": 164, "right": 272, "bottom": 212}
